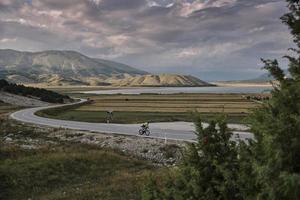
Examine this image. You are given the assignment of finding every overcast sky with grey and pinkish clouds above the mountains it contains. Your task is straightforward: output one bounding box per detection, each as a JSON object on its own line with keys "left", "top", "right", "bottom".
{"left": 0, "top": 0, "right": 291, "bottom": 80}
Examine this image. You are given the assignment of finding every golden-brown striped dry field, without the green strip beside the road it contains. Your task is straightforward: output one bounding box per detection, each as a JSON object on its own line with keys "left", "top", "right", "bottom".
{"left": 76, "top": 94, "right": 258, "bottom": 114}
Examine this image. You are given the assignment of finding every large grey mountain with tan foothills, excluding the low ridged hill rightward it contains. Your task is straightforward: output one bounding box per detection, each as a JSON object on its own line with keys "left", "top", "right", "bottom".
{"left": 0, "top": 50, "right": 147, "bottom": 85}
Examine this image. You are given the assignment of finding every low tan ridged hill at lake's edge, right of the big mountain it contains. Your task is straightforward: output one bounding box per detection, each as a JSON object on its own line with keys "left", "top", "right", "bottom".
{"left": 111, "top": 74, "right": 211, "bottom": 87}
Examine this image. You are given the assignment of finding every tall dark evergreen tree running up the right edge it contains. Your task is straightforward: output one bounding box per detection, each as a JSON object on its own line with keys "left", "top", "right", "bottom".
{"left": 251, "top": 0, "right": 300, "bottom": 200}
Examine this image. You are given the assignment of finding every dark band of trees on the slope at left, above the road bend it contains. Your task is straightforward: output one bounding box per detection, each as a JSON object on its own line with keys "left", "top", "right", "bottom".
{"left": 0, "top": 79, "right": 70, "bottom": 103}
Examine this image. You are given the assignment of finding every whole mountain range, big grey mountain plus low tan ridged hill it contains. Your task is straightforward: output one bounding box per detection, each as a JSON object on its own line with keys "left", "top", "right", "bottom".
{"left": 0, "top": 49, "right": 209, "bottom": 86}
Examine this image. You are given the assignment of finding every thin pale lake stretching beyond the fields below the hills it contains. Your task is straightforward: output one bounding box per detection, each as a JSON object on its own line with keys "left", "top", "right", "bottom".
{"left": 82, "top": 86, "right": 272, "bottom": 94}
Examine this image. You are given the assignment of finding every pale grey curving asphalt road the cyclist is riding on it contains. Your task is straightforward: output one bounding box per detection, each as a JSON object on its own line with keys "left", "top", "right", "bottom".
{"left": 10, "top": 99, "right": 253, "bottom": 142}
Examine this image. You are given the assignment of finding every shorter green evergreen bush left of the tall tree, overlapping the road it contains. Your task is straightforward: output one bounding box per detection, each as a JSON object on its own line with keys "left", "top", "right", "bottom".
{"left": 143, "top": 118, "right": 242, "bottom": 200}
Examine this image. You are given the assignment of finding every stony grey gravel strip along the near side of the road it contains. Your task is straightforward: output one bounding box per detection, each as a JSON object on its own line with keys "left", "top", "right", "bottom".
{"left": 2, "top": 115, "right": 187, "bottom": 166}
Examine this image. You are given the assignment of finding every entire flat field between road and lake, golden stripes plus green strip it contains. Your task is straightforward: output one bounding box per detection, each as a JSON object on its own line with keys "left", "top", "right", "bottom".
{"left": 39, "top": 94, "right": 259, "bottom": 123}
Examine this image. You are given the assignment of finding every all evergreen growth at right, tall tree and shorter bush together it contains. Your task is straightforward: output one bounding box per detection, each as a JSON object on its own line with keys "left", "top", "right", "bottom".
{"left": 143, "top": 0, "right": 300, "bottom": 200}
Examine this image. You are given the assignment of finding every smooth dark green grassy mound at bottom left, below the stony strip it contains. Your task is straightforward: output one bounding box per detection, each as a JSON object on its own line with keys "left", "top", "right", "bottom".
{"left": 0, "top": 145, "right": 151, "bottom": 199}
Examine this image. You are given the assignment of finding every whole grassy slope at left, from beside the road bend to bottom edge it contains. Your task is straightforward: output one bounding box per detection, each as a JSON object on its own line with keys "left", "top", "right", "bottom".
{"left": 0, "top": 104, "right": 161, "bottom": 200}
